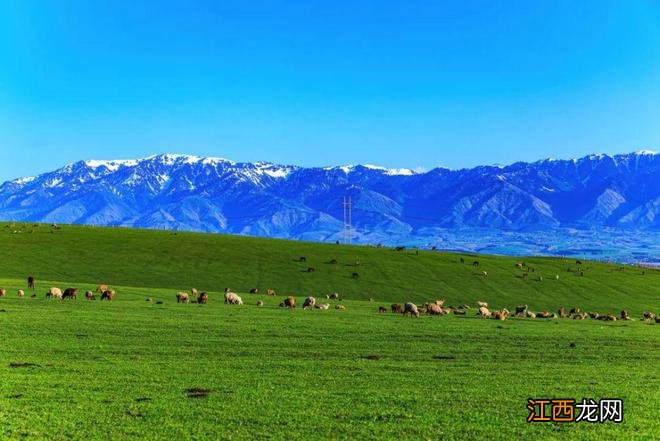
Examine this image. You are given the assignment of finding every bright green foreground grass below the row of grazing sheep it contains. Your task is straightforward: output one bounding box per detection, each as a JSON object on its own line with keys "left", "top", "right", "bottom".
{"left": 0, "top": 280, "right": 660, "bottom": 440}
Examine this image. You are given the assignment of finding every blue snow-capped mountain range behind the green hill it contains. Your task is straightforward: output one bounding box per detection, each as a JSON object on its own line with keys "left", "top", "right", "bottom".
{"left": 0, "top": 151, "right": 660, "bottom": 243}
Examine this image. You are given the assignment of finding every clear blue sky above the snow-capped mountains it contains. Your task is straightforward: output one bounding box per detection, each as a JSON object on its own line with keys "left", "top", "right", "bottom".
{"left": 0, "top": 0, "right": 660, "bottom": 181}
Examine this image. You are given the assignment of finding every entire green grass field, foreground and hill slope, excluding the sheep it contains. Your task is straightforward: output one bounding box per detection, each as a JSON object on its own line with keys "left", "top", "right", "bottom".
{"left": 0, "top": 225, "right": 660, "bottom": 440}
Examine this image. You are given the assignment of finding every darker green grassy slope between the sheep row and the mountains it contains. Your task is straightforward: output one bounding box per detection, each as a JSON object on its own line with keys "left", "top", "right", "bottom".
{"left": 0, "top": 223, "right": 660, "bottom": 315}
